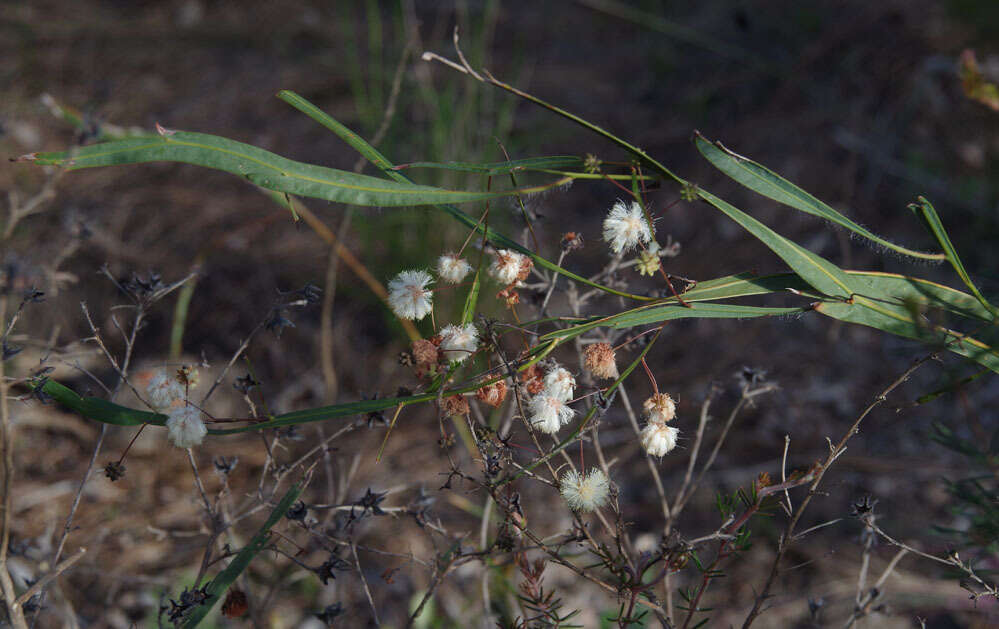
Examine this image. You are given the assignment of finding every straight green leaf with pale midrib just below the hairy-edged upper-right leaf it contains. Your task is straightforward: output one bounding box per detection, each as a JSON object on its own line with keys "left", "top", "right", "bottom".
{"left": 697, "top": 189, "right": 855, "bottom": 298}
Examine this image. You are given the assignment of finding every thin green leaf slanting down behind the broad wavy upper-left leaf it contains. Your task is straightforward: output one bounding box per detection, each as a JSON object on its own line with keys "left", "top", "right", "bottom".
{"left": 278, "top": 90, "right": 652, "bottom": 301}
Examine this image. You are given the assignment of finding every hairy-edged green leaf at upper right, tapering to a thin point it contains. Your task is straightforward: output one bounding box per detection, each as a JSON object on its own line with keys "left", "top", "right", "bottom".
{"left": 694, "top": 133, "right": 944, "bottom": 260}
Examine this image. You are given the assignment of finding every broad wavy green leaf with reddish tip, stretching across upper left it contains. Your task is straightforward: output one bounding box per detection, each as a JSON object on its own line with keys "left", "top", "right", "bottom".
{"left": 22, "top": 131, "right": 558, "bottom": 206}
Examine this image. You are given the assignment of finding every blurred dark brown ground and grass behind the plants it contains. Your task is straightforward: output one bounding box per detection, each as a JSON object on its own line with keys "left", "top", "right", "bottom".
{"left": 0, "top": 0, "right": 999, "bottom": 627}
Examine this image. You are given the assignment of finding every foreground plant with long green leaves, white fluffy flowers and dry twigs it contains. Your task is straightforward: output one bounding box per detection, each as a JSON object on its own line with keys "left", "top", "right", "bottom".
{"left": 3, "top": 38, "right": 999, "bottom": 628}
